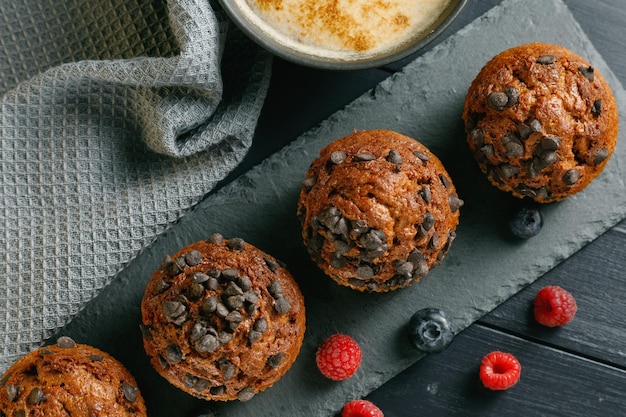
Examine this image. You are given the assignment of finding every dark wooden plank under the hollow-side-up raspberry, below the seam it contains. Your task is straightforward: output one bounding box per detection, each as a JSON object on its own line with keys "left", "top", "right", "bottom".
{"left": 367, "top": 324, "right": 626, "bottom": 417}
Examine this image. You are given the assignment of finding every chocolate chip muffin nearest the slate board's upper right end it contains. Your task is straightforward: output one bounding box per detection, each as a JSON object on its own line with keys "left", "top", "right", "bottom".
{"left": 463, "top": 43, "right": 618, "bottom": 203}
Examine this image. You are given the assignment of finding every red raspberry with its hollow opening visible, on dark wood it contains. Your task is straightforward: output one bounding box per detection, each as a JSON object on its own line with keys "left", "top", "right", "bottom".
{"left": 480, "top": 351, "right": 522, "bottom": 390}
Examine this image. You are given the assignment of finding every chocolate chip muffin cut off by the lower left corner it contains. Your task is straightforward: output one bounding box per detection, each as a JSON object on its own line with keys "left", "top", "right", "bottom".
{"left": 0, "top": 336, "right": 147, "bottom": 417}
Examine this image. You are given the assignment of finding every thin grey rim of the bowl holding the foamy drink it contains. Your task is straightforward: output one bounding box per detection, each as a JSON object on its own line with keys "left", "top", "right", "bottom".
{"left": 219, "top": 0, "right": 468, "bottom": 70}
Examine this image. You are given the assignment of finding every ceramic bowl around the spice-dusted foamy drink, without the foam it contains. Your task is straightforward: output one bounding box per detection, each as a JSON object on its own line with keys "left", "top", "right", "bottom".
{"left": 220, "top": 0, "right": 467, "bottom": 70}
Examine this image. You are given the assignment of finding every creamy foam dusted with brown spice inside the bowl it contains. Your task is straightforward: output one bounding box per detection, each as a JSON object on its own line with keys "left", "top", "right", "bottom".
{"left": 236, "top": 0, "right": 451, "bottom": 58}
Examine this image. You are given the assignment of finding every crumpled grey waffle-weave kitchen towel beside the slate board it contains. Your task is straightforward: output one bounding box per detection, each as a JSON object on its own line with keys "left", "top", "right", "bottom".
{"left": 0, "top": 0, "right": 271, "bottom": 371}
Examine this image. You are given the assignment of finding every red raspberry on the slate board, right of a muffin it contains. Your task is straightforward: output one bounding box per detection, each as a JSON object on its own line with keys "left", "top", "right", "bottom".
{"left": 315, "top": 334, "right": 362, "bottom": 381}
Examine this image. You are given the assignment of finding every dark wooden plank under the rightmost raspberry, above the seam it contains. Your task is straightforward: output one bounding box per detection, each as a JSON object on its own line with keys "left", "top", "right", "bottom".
{"left": 481, "top": 222, "right": 626, "bottom": 366}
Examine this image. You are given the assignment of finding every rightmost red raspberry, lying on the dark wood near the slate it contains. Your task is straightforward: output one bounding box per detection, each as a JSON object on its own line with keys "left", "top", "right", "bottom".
{"left": 534, "top": 285, "right": 578, "bottom": 327}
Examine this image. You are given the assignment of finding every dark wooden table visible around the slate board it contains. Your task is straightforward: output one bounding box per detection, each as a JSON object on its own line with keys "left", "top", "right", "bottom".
{"left": 225, "top": 0, "right": 626, "bottom": 417}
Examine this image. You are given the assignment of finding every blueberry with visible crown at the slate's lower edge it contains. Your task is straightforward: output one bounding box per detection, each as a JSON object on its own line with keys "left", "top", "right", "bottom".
{"left": 408, "top": 308, "right": 455, "bottom": 353}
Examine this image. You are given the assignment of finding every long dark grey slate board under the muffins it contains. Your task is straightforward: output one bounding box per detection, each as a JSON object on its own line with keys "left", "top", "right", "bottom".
{"left": 57, "top": 0, "right": 626, "bottom": 417}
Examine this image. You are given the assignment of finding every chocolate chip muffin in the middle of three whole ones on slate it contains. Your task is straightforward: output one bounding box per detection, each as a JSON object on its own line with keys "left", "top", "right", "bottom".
{"left": 298, "top": 130, "right": 463, "bottom": 292}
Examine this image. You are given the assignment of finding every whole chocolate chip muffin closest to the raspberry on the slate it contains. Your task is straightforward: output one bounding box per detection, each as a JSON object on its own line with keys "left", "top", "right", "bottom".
{"left": 141, "top": 234, "right": 305, "bottom": 401}
